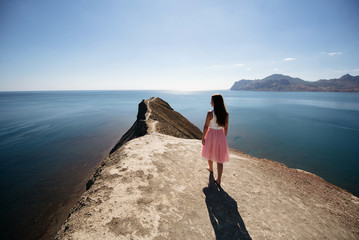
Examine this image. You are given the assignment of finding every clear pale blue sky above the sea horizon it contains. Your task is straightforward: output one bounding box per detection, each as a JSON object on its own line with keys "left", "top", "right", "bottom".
{"left": 0, "top": 0, "right": 359, "bottom": 91}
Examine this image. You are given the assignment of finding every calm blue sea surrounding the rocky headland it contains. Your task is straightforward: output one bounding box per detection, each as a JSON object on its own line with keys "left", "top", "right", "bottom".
{"left": 0, "top": 90, "right": 359, "bottom": 239}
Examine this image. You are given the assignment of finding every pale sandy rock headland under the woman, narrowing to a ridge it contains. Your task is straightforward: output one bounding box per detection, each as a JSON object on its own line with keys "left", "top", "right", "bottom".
{"left": 56, "top": 98, "right": 359, "bottom": 240}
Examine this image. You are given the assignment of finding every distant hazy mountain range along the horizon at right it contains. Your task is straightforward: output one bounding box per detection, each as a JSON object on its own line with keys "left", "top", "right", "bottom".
{"left": 231, "top": 74, "right": 359, "bottom": 92}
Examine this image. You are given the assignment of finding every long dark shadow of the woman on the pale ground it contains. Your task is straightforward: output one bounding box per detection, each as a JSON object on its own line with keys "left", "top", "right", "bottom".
{"left": 203, "top": 173, "right": 252, "bottom": 240}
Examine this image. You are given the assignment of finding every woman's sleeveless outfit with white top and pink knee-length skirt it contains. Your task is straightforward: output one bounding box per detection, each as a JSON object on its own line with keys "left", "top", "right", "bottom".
{"left": 201, "top": 111, "right": 229, "bottom": 163}
